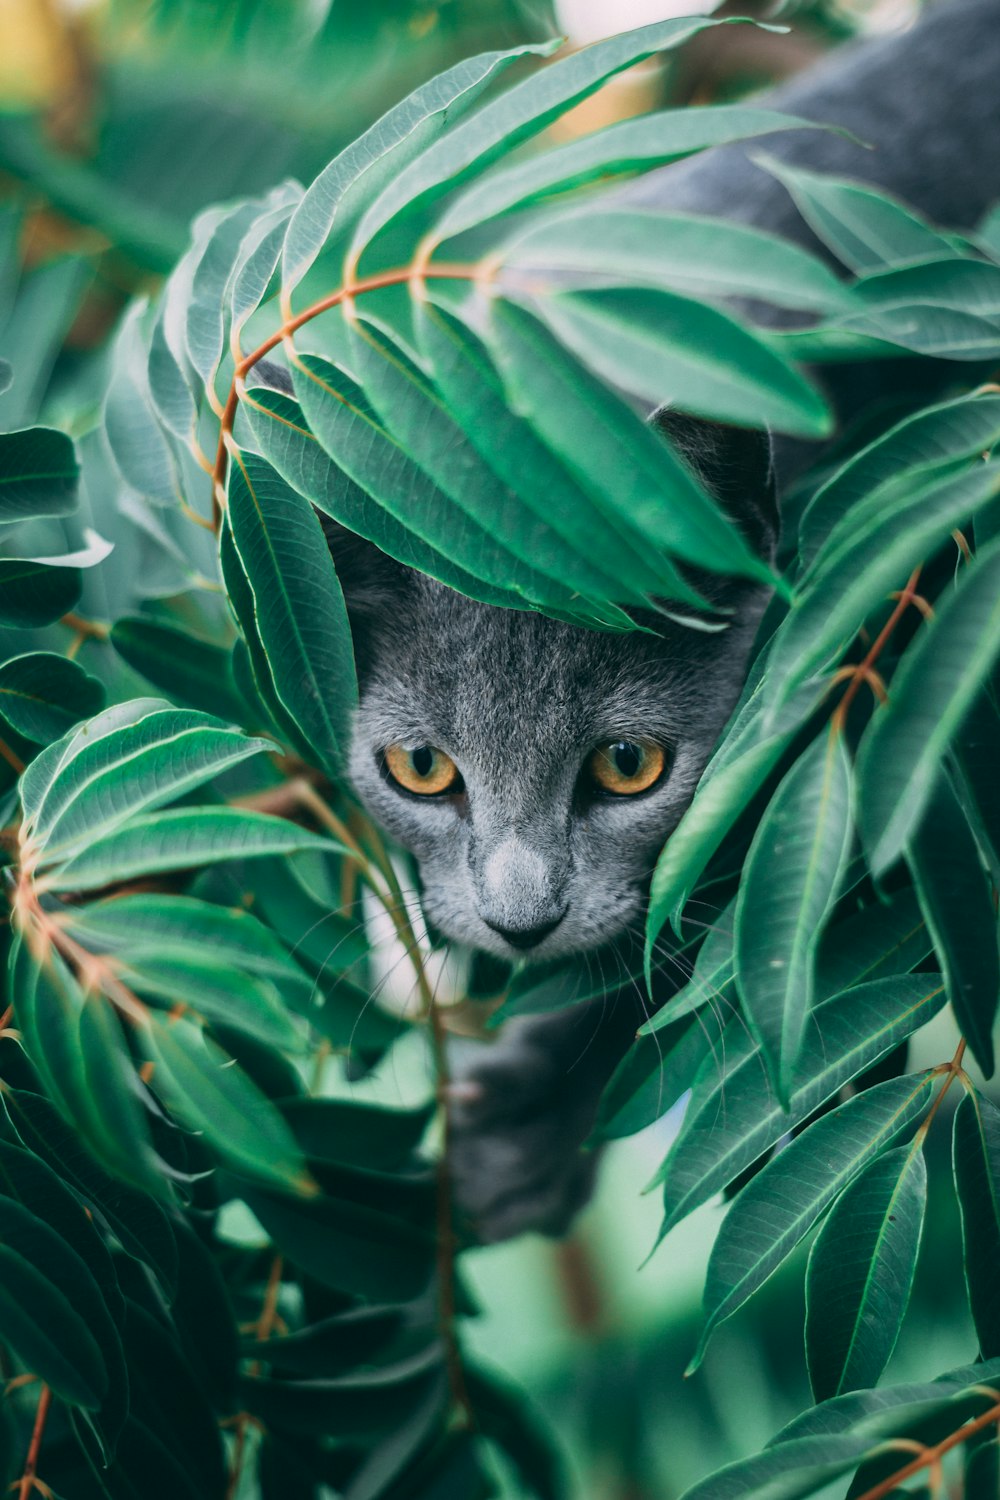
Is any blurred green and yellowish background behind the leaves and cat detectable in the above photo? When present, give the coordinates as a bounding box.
[0,0,959,1500]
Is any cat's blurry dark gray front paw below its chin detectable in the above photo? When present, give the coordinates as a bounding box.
[448,1037,597,1244]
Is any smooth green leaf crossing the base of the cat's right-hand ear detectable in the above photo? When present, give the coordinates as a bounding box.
[486,299,774,584]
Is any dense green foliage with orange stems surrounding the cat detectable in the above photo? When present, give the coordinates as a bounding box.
[0,8,1000,1500]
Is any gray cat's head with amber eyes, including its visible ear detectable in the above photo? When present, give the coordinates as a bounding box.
[328,414,777,960]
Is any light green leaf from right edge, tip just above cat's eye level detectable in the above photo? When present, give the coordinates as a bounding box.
[768,464,1000,707]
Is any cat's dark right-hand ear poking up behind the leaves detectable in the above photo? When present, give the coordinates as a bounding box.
[651,407,780,563]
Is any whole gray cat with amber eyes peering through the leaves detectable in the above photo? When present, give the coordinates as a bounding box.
[305,0,1000,1241]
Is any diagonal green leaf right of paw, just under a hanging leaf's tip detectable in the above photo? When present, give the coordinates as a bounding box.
[649,974,945,1239]
